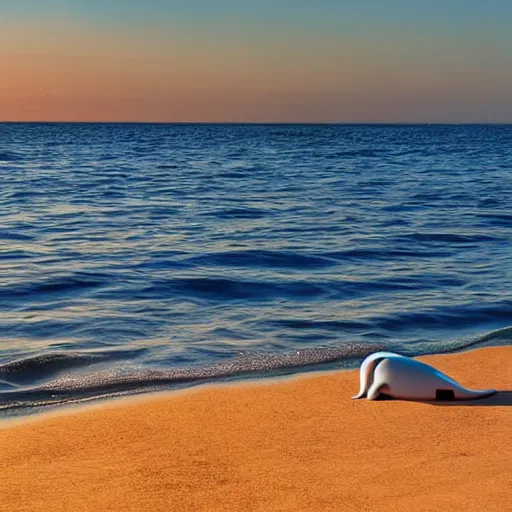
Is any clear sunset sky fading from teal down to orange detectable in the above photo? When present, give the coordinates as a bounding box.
[0,0,512,123]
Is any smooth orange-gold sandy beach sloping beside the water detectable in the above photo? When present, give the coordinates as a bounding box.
[0,347,512,512]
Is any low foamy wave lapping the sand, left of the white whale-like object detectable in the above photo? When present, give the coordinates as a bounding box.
[0,343,383,413]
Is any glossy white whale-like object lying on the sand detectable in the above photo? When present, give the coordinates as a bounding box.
[353,352,496,401]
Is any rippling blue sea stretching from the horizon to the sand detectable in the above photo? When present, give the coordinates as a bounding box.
[0,124,512,415]
